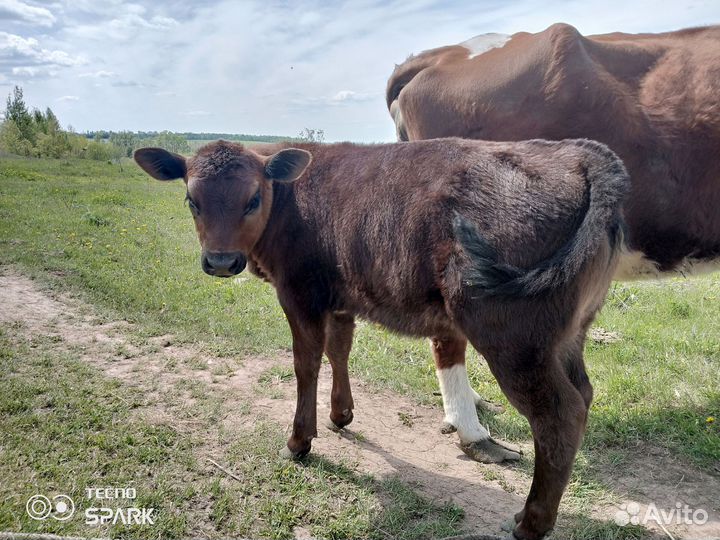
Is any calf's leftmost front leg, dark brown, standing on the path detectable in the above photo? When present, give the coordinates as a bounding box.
[281,315,325,458]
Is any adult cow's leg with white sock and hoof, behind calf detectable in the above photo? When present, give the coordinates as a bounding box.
[431,336,520,463]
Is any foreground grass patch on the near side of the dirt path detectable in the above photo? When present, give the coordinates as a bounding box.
[0,329,462,540]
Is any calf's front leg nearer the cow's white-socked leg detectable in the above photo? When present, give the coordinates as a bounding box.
[325,313,355,431]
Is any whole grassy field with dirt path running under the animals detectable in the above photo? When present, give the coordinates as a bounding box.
[0,154,720,540]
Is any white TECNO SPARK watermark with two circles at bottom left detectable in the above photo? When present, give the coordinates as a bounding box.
[25,487,155,525]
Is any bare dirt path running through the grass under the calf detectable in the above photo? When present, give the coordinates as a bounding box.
[0,270,720,539]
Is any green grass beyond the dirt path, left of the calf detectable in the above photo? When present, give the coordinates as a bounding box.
[0,159,290,354]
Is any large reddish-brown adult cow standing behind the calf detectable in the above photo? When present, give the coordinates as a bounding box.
[387,24,720,442]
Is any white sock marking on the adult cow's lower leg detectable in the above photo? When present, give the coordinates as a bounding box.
[437,364,490,443]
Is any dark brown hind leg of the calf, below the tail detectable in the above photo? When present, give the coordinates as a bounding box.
[478,347,592,540]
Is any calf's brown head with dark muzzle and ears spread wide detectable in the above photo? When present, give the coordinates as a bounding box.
[134,141,311,277]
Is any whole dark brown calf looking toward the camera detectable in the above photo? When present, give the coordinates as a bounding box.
[135,139,627,540]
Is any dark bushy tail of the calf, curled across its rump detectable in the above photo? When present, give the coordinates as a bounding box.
[453,140,629,297]
